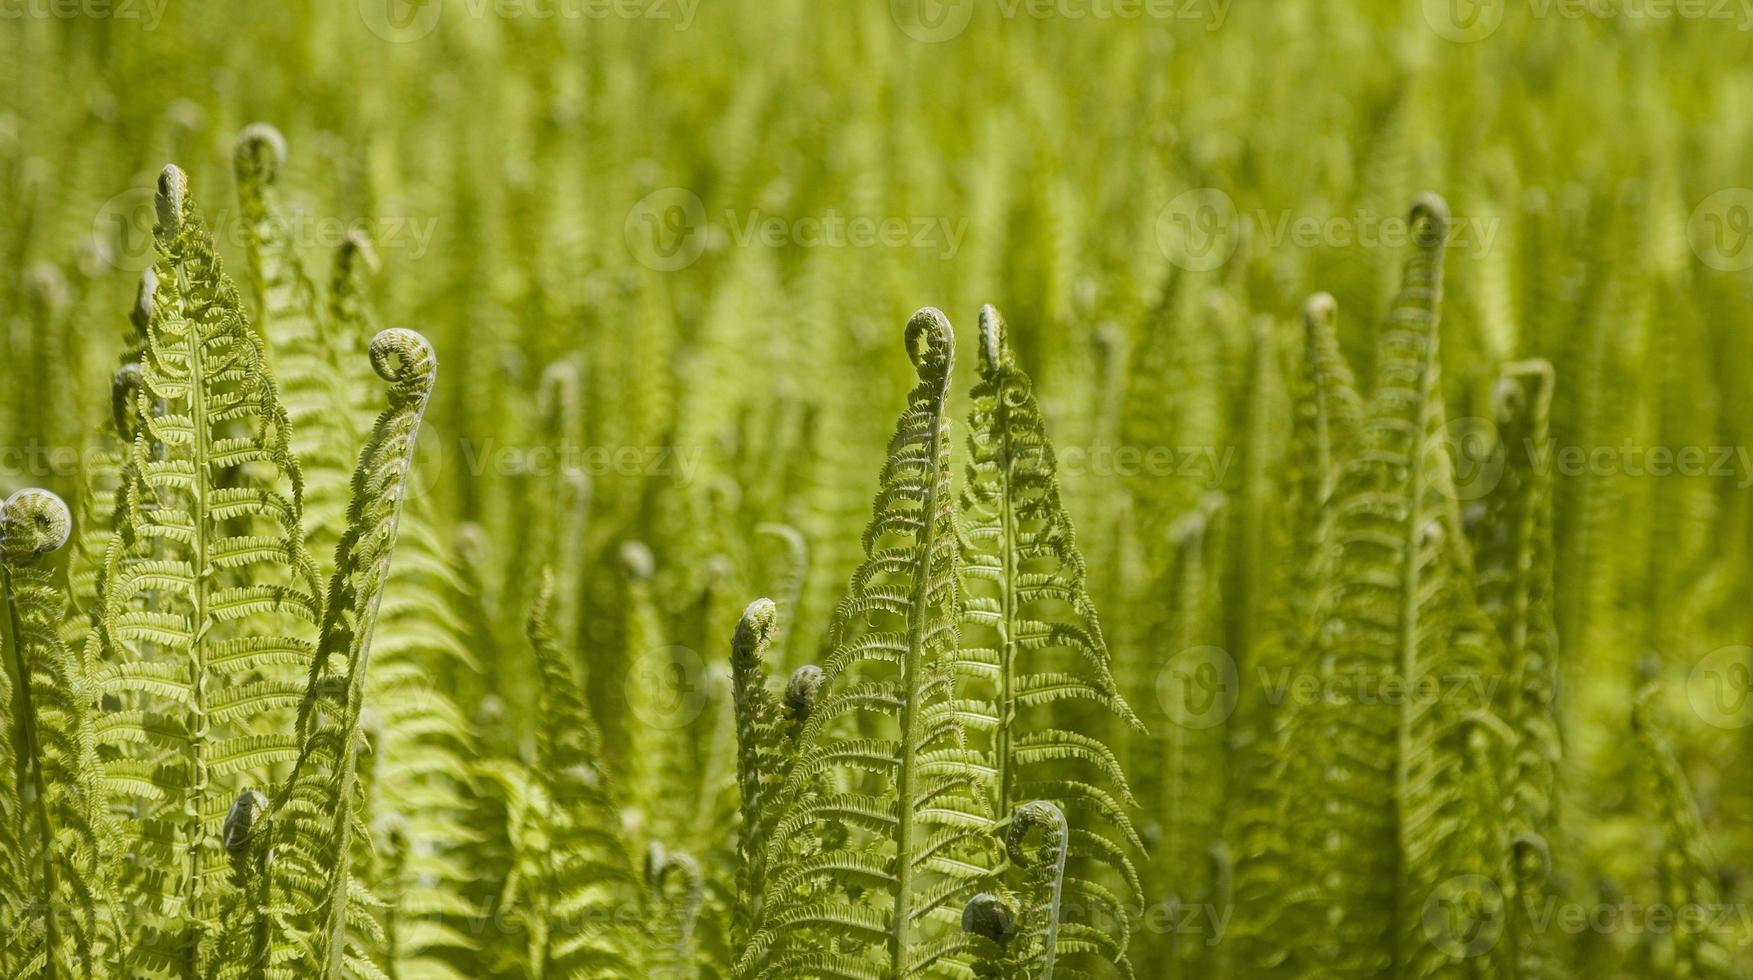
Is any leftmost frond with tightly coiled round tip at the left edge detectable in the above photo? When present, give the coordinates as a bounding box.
[0,489,116,978]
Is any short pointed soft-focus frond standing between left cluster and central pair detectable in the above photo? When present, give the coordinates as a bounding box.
[515,573,645,978]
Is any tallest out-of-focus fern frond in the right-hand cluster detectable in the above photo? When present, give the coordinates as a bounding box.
[1287,195,1502,976]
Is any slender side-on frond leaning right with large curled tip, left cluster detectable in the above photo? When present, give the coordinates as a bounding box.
[250,330,438,980]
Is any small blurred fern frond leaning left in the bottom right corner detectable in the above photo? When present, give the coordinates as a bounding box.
[1632,687,1749,980]
